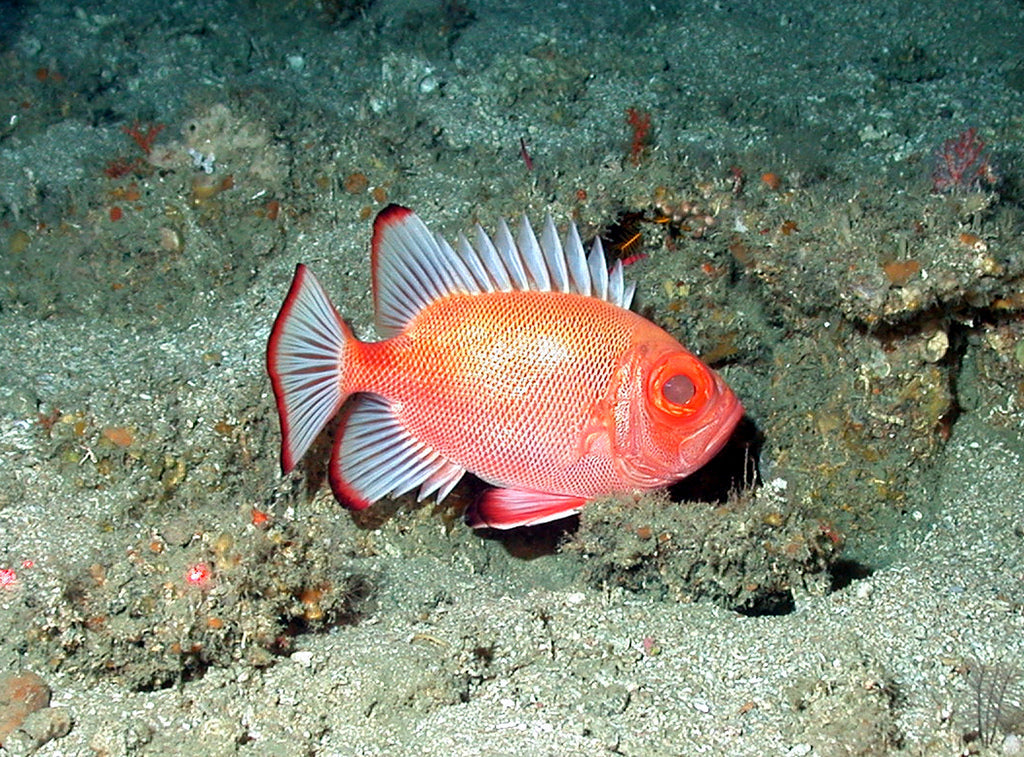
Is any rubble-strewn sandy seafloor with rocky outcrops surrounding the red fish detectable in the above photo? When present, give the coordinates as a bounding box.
[0,0,1024,756]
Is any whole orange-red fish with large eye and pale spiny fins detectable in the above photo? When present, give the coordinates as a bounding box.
[267,205,743,529]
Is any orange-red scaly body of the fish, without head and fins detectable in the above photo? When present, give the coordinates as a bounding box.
[364,293,636,495]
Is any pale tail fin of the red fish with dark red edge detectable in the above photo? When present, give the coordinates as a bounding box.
[266,263,354,473]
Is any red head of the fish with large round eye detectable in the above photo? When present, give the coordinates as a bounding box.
[614,330,743,489]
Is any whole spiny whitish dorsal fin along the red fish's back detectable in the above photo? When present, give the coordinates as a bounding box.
[373,205,634,337]
